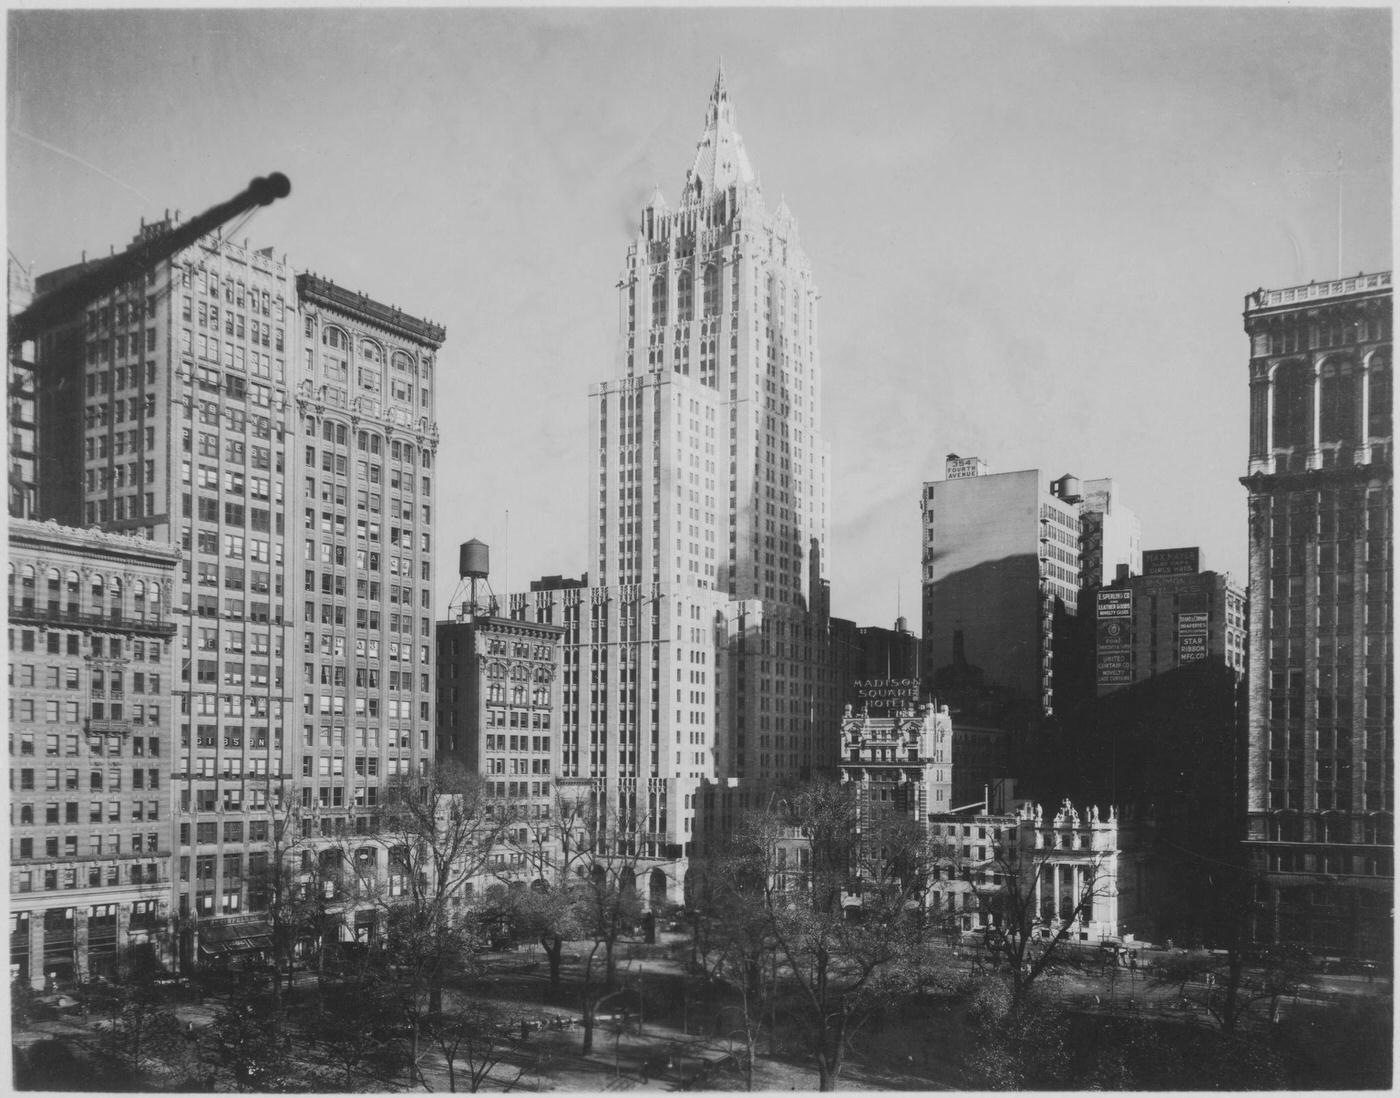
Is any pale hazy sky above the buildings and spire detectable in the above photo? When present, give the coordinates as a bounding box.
[7,7,1392,629]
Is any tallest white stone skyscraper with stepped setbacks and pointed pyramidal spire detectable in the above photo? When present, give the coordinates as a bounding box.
[511,69,837,890]
